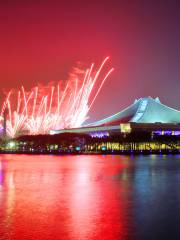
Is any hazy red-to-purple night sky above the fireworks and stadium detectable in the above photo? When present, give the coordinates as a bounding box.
[0,0,180,122]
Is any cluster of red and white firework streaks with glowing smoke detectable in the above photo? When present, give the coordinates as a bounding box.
[0,57,113,137]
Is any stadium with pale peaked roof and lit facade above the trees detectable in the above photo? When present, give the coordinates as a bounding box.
[50,97,180,137]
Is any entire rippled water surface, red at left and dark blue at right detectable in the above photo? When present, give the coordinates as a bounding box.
[0,155,180,240]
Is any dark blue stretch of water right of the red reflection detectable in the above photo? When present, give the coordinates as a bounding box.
[132,155,180,239]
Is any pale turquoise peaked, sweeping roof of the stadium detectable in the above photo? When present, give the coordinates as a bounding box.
[87,97,180,127]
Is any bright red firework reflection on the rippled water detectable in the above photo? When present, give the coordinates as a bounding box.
[0,155,131,240]
